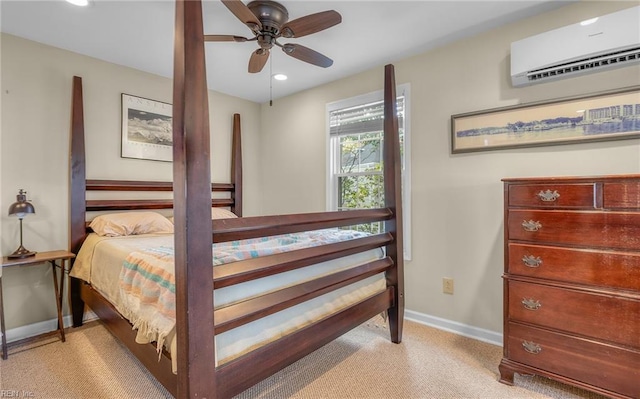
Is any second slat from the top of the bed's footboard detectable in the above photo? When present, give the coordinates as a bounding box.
[213,233,393,288]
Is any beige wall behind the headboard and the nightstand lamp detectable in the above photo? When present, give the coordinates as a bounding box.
[0,34,261,329]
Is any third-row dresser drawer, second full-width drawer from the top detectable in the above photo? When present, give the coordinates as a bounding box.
[507,243,640,291]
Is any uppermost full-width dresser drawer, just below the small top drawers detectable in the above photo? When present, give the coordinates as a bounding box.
[507,209,640,250]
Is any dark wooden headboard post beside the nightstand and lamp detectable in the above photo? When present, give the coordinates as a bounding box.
[69,76,86,327]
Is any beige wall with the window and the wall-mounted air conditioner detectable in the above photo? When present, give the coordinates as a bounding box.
[261,1,640,332]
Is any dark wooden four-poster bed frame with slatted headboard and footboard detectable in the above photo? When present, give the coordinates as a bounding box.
[70,0,404,398]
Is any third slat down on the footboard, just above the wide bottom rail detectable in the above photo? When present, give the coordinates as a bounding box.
[213,258,393,334]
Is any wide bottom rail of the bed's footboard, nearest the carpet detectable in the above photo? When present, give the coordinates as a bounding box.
[216,287,395,398]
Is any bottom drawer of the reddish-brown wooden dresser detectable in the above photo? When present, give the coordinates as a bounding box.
[506,323,640,398]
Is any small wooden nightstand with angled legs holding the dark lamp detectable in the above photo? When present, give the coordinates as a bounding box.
[0,250,75,359]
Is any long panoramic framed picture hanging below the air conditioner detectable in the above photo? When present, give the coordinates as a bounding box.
[451,86,640,153]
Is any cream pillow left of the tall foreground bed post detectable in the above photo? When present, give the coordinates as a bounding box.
[89,212,173,237]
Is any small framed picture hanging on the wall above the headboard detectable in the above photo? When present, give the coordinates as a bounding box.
[122,93,173,162]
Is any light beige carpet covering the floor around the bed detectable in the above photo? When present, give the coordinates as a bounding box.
[0,319,603,399]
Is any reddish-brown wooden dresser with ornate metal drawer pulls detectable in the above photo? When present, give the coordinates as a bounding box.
[499,175,640,399]
